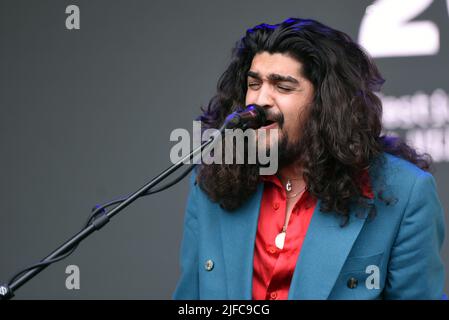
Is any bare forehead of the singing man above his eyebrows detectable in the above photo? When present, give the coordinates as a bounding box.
[250,52,302,79]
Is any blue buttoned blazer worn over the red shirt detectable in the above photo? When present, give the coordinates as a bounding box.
[173,153,444,299]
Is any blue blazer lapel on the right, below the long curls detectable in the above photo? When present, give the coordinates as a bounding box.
[288,200,369,300]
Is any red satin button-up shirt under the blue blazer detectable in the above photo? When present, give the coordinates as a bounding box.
[253,171,374,300]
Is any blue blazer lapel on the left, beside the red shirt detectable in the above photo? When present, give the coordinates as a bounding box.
[220,183,263,300]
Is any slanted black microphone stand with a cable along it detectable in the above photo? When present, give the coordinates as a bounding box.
[0,121,228,300]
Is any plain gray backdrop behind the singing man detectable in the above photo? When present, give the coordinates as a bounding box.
[0,0,449,299]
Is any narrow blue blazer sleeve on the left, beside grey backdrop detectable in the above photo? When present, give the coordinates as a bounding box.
[173,171,199,300]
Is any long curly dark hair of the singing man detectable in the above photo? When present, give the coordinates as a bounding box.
[197,18,431,225]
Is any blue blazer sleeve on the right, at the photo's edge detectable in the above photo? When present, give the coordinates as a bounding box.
[384,173,445,299]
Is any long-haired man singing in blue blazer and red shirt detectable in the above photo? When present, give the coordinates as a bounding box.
[174,19,444,300]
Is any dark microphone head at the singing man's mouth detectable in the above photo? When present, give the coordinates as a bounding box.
[224,104,267,129]
